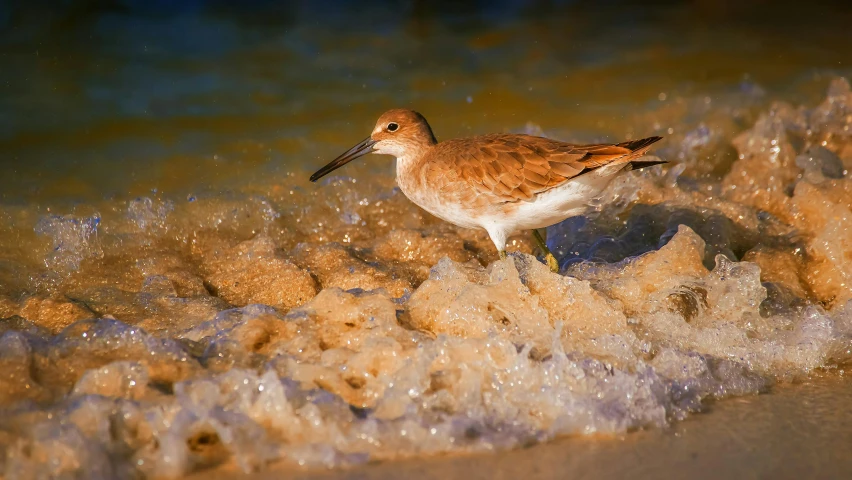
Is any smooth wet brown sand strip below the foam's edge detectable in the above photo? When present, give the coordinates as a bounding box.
[201,373,852,480]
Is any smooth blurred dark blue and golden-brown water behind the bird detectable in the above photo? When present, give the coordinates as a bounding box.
[0,0,852,205]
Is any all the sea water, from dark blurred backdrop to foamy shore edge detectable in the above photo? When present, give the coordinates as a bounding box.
[0,1,852,478]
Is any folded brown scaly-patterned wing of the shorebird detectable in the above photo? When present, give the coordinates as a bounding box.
[450,134,660,202]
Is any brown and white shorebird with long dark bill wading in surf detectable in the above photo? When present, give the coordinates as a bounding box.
[311,109,665,272]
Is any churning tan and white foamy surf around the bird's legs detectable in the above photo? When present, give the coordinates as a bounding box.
[0,80,852,478]
